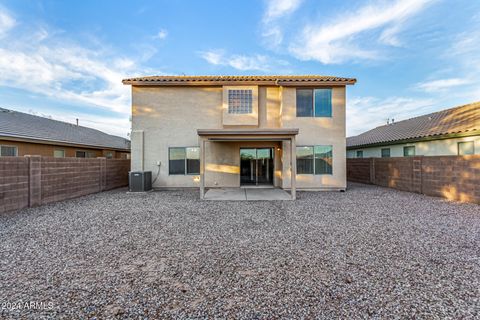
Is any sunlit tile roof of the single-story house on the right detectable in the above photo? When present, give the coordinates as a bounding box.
[347,102,480,148]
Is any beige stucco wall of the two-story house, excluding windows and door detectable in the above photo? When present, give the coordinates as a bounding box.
[131,86,346,189]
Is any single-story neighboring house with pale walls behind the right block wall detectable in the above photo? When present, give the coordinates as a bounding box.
[347,102,480,158]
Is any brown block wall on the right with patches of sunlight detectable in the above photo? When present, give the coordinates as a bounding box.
[347,155,480,203]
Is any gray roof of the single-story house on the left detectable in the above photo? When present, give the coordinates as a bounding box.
[0,108,130,150]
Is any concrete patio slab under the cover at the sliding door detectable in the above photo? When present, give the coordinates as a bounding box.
[205,188,291,201]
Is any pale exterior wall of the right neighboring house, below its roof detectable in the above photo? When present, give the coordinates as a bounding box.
[347,135,480,158]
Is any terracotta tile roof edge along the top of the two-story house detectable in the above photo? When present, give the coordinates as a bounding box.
[122,75,357,85]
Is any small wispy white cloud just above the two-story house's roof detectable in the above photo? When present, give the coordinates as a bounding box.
[200,50,288,71]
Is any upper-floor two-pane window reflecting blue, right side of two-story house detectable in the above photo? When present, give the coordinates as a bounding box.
[297,89,332,117]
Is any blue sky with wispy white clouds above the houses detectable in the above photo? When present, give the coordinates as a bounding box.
[0,0,480,136]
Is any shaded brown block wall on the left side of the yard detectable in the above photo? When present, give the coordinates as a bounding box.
[0,156,130,213]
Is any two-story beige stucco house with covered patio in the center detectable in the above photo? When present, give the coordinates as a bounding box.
[123,75,356,198]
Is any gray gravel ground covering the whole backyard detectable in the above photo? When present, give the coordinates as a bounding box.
[0,184,480,319]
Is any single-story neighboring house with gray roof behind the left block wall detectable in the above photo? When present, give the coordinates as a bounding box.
[0,108,130,159]
